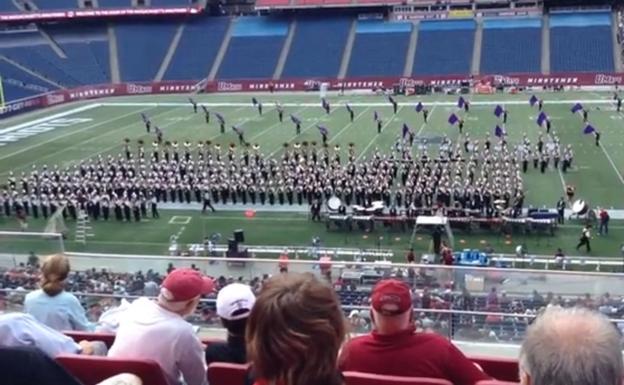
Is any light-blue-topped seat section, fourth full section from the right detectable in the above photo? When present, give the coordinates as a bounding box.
[347,20,412,77]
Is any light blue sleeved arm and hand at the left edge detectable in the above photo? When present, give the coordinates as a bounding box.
[0,313,106,358]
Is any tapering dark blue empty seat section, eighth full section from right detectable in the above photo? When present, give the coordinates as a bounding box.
[115,23,178,82]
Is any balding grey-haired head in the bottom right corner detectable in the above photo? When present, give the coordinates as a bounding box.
[520,307,624,385]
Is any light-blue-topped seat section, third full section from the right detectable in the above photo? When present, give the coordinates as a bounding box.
[413,20,475,75]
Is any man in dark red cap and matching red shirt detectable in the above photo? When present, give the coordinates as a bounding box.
[339,279,490,385]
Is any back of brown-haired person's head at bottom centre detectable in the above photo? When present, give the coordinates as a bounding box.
[246,273,346,385]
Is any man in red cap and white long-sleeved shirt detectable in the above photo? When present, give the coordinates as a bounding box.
[108,269,214,385]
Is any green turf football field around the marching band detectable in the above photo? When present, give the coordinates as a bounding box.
[0,92,624,258]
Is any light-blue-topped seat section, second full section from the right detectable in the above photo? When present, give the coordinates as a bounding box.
[480,18,542,74]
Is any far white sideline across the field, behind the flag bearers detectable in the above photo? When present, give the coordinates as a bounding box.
[100,99,613,109]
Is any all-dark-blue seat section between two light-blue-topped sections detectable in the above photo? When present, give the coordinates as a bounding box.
[282,17,352,78]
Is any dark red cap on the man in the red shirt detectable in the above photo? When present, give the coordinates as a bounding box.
[371,279,412,316]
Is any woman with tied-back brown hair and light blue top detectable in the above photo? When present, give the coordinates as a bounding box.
[24,254,93,331]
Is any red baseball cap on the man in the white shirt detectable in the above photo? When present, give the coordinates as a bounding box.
[160,268,214,302]
